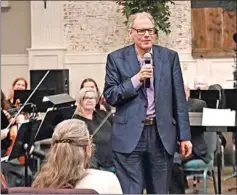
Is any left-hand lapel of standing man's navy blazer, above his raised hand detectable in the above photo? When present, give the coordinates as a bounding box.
[125,44,147,97]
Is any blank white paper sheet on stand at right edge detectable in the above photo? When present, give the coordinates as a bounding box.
[202,108,236,127]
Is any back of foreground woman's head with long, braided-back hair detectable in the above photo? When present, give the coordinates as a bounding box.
[32,119,92,188]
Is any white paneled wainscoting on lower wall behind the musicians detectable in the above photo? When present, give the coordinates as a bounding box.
[1,51,234,90]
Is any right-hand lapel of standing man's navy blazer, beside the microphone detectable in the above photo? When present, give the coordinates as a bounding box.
[152,46,163,101]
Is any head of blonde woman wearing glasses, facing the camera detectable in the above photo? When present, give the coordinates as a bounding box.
[75,87,98,115]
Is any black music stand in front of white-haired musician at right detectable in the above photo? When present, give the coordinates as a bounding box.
[190,90,220,108]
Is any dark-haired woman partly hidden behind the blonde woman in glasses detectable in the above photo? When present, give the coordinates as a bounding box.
[80,78,111,112]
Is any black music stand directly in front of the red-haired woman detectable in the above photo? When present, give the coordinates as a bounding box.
[13,90,55,112]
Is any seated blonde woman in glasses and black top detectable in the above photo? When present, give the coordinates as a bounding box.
[73,88,113,170]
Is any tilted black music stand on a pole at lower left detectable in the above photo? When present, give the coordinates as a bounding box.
[7,120,41,187]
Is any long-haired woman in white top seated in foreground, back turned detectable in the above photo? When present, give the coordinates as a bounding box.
[32,119,122,194]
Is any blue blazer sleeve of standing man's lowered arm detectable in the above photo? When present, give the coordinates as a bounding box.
[173,53,191,141]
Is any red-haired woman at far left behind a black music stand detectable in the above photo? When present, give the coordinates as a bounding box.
[8,77,28,107]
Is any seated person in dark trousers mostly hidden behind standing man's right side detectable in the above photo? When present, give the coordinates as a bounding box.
[169,85,211,194]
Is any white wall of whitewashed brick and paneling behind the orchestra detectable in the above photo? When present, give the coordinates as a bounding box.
[1,1,234,99]
